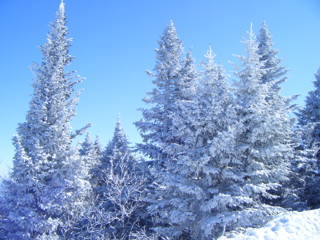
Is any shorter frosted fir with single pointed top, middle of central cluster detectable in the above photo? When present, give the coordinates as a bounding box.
[192,48,239,239]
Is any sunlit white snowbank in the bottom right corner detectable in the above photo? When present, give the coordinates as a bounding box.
[219,209,320,240]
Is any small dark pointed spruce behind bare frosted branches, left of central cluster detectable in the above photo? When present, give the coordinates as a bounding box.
[80,118,146,239]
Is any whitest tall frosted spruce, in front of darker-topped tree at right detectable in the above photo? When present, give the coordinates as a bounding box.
[230,25,292,227]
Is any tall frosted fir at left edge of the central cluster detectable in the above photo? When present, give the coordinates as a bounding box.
[135,21,186,238]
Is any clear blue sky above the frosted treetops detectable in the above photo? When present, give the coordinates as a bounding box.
[0,0,320,175]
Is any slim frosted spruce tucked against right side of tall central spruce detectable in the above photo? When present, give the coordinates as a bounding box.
[149,50,199,237]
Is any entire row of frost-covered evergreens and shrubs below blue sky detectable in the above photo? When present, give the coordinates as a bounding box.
[0,2,320,240]
